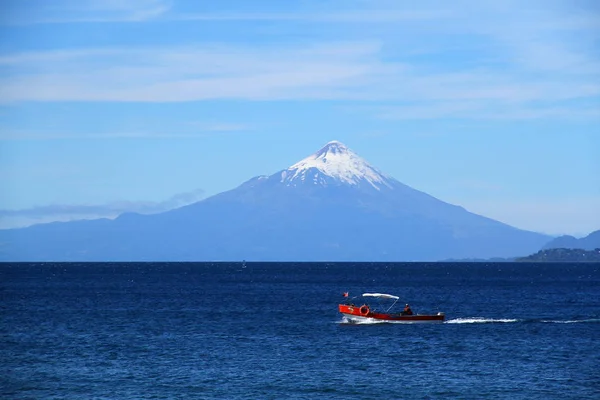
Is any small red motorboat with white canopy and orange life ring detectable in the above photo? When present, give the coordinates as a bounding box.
[339,293,446,324]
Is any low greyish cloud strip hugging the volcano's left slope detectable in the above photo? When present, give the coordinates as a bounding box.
[0,189,205,229]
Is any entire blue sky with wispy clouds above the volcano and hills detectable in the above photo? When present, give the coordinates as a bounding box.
[0,0,600,235]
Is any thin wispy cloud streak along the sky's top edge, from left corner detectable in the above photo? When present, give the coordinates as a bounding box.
[0,0,453,25]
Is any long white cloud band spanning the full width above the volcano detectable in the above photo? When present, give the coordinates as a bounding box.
[0,43,600,110]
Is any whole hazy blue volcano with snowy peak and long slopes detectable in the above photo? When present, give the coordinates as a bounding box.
[0,142,549,261]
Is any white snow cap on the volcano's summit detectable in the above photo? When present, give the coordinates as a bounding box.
[281,140,392,190]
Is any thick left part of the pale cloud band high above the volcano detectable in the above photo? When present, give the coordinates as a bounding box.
[0,43,380,102]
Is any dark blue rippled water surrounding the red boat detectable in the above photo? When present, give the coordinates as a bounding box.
[0,263,600,399]
